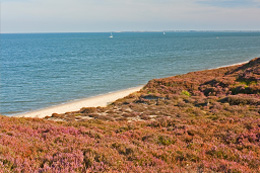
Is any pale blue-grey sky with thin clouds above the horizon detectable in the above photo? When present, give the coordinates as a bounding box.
[0,0,260,33]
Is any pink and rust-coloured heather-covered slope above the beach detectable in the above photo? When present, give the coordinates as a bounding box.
[0,58,260,172]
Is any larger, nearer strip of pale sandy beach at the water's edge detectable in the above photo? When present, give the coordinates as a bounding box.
[13,86,143,118]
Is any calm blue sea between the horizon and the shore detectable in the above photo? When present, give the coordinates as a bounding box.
[0,32,260,115]
